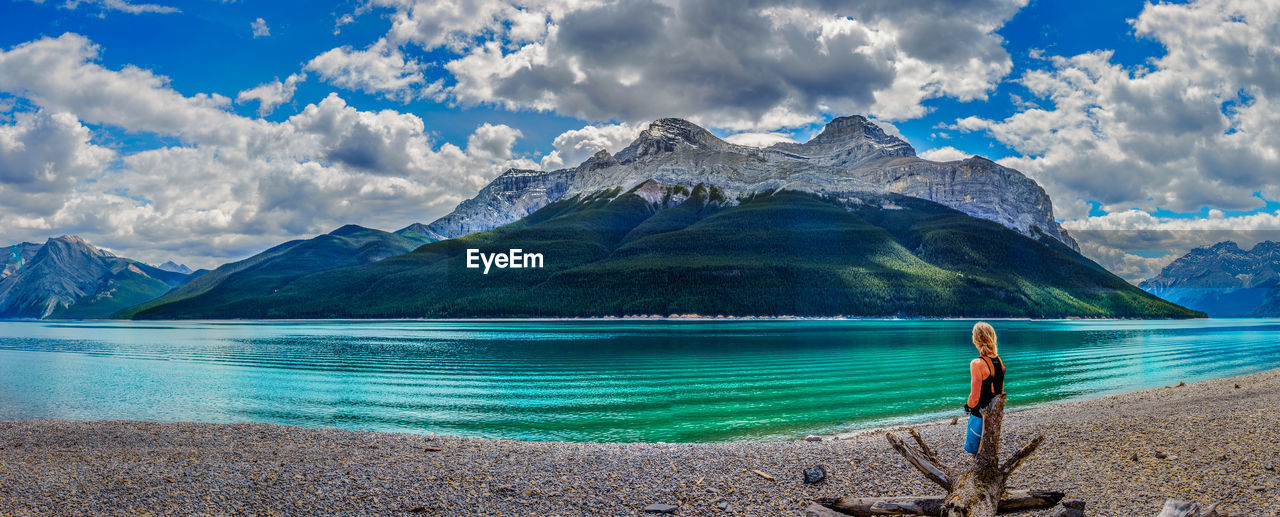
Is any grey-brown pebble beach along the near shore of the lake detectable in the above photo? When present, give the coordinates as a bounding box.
[0,370,1280,516]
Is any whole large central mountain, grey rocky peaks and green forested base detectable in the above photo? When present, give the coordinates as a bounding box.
[118,116,1187,319]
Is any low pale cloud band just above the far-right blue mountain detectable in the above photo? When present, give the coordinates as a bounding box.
[1064,210,1280,283]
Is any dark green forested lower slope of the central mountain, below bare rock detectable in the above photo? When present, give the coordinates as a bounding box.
[138,182,1198,317]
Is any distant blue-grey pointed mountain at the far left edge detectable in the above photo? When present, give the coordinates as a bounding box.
[0,235,187,319]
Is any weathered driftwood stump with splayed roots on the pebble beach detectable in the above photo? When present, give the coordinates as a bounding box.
[819,394,1062,517]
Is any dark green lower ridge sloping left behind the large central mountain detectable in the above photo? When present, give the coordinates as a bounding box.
[116,224,429,317]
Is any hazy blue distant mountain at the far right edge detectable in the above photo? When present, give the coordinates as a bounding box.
[1139,241,1280,317]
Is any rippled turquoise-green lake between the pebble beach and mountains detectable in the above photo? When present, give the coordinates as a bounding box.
[0,320,1280,441]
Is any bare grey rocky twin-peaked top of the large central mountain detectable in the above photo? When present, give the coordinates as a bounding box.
[401,116,1079,250]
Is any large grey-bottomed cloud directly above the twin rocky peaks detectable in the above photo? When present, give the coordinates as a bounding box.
[348,0,1025,132]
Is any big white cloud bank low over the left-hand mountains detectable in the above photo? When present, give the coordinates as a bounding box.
[0,35,536,266]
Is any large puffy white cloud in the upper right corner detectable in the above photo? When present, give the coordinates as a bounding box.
[954,0,1280,216]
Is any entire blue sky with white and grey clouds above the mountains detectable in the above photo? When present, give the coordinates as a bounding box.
[0,0,1280,280]
